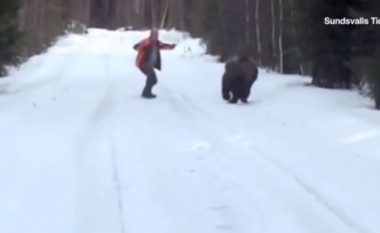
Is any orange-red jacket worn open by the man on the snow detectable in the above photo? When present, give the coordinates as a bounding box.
[133,38,175,70]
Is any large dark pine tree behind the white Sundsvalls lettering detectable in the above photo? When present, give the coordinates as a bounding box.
[297,0,359,88]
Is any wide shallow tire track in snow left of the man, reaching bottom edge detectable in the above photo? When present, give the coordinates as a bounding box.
[73,50,126,233]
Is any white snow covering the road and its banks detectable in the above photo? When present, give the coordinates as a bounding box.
[0,29,380,233]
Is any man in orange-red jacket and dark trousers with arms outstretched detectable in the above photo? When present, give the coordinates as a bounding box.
[133,29,175,99]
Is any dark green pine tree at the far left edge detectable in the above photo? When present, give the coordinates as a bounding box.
[0,0,22,77]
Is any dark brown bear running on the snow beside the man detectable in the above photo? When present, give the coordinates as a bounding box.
[222,56,258,103]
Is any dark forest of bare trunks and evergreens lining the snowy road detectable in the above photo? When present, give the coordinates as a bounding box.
[0,0,380,109]
